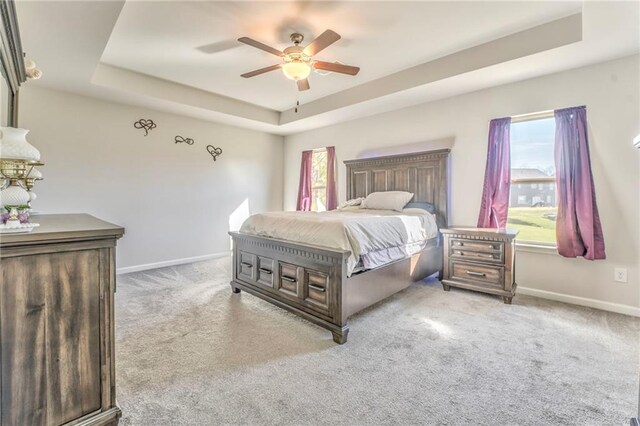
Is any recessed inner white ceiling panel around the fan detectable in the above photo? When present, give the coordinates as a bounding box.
[102,2,581,111]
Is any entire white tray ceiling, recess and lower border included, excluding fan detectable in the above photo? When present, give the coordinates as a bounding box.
[16,0,640,134]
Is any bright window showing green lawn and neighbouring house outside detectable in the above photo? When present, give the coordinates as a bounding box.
[507,113,557,245]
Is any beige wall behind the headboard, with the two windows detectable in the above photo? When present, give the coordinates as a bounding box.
[284,56,640,312]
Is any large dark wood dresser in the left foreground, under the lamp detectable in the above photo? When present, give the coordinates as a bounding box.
[0,214,124,426]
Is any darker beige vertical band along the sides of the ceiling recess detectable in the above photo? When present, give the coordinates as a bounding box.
[91,13,582,133]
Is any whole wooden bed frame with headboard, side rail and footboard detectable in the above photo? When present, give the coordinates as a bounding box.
[229,149,449,344]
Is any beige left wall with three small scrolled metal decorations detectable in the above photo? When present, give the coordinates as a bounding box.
[19,84,283,267]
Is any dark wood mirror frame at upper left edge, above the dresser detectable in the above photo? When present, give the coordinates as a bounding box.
[0,0,27,127]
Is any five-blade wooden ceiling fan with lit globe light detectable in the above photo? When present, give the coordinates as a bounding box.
[238,30,360,91]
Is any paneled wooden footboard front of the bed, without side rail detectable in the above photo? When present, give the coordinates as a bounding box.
[229,232,351,344]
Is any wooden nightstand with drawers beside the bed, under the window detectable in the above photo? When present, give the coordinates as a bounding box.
[440,227,518,304]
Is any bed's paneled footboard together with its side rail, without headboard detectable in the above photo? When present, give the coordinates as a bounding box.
[229,232,442,344]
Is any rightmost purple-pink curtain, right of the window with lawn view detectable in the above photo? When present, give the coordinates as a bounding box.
[555,106,606,260]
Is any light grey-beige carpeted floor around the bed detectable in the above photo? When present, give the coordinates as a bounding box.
[116,258,640,426]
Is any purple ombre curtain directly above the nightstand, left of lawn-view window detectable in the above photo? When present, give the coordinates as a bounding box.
[478,117,511,228]
